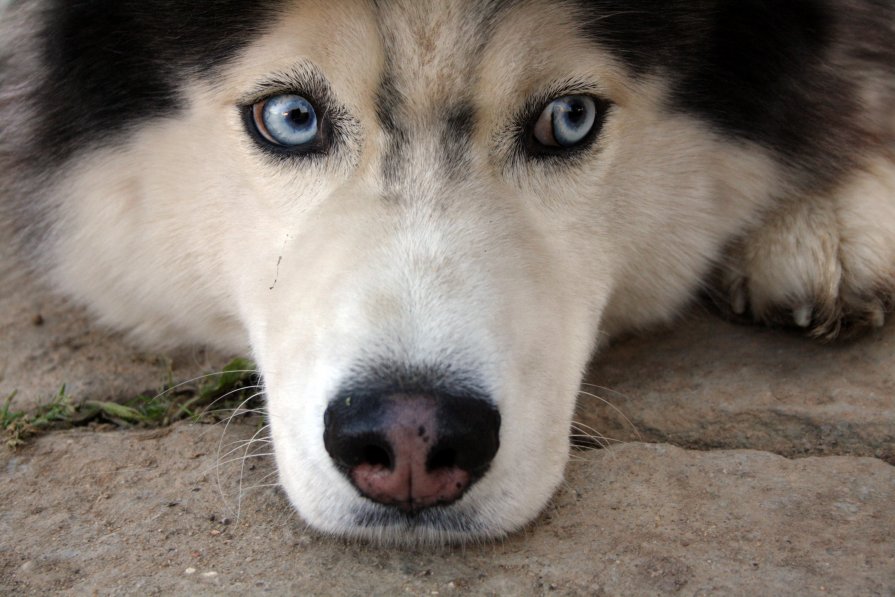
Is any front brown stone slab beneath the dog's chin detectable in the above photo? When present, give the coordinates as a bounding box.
[0,424,895,595]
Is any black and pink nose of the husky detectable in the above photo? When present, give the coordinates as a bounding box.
[323,393,500,512]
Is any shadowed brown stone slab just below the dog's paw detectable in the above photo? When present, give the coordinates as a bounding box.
[577,312,895,464]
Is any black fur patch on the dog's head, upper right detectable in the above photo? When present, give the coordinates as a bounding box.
[582,0,895,185]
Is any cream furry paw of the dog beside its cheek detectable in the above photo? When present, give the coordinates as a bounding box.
[721,161,895,339]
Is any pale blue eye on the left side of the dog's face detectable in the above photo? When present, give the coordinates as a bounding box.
[252,95,320,148]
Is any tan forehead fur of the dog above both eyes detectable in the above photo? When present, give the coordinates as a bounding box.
[231,0,624,110]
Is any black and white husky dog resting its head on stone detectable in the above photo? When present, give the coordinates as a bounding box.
[0,0,895,542]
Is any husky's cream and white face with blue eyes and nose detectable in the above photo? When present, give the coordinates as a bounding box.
[40,0,764,541]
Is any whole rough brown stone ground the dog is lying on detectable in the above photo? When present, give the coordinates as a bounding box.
[0,262,895,595]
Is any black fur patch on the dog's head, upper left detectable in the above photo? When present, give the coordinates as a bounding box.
[37,0,281,165]
